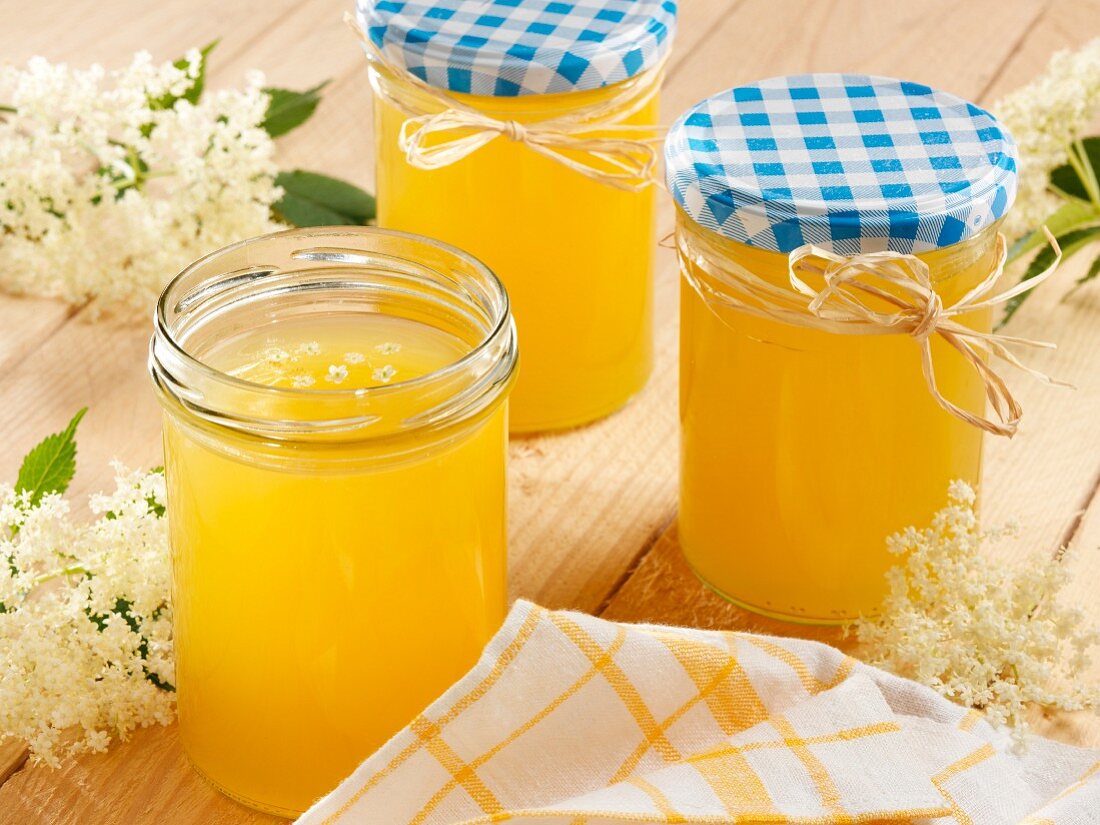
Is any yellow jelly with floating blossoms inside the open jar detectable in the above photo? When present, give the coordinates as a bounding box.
[165,315,506,815]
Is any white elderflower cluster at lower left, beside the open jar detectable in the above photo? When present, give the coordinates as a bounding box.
[0,465,175,766]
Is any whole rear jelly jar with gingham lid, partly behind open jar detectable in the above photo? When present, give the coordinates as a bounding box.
[359,0,677,432]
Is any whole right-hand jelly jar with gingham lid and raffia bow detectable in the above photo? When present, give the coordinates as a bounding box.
[666,74,1016,624]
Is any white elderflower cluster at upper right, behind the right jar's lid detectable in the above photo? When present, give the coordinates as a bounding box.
[993,37,1100,240]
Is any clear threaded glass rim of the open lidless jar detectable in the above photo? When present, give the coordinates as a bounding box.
[149,227,518,437]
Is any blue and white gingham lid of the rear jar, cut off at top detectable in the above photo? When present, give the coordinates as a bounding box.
[358,0,677,97]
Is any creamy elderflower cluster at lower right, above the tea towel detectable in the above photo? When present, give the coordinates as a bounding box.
[856,482,1100,744]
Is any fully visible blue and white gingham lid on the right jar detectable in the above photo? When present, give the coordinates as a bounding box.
[664,74,1016,255]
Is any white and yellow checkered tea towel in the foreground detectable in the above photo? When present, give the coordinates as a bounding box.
[299,602,1100,825]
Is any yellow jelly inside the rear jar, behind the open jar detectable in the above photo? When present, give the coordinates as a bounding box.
[375,78,657,432]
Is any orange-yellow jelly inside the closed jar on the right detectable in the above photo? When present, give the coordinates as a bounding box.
[679,213,996,624]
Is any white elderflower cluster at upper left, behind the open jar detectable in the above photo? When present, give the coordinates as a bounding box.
[0,51,282,311]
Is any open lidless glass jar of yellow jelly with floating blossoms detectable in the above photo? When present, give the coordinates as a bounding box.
[150,228,517,816]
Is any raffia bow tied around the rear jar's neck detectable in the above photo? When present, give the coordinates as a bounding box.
[344,13,663,191]
